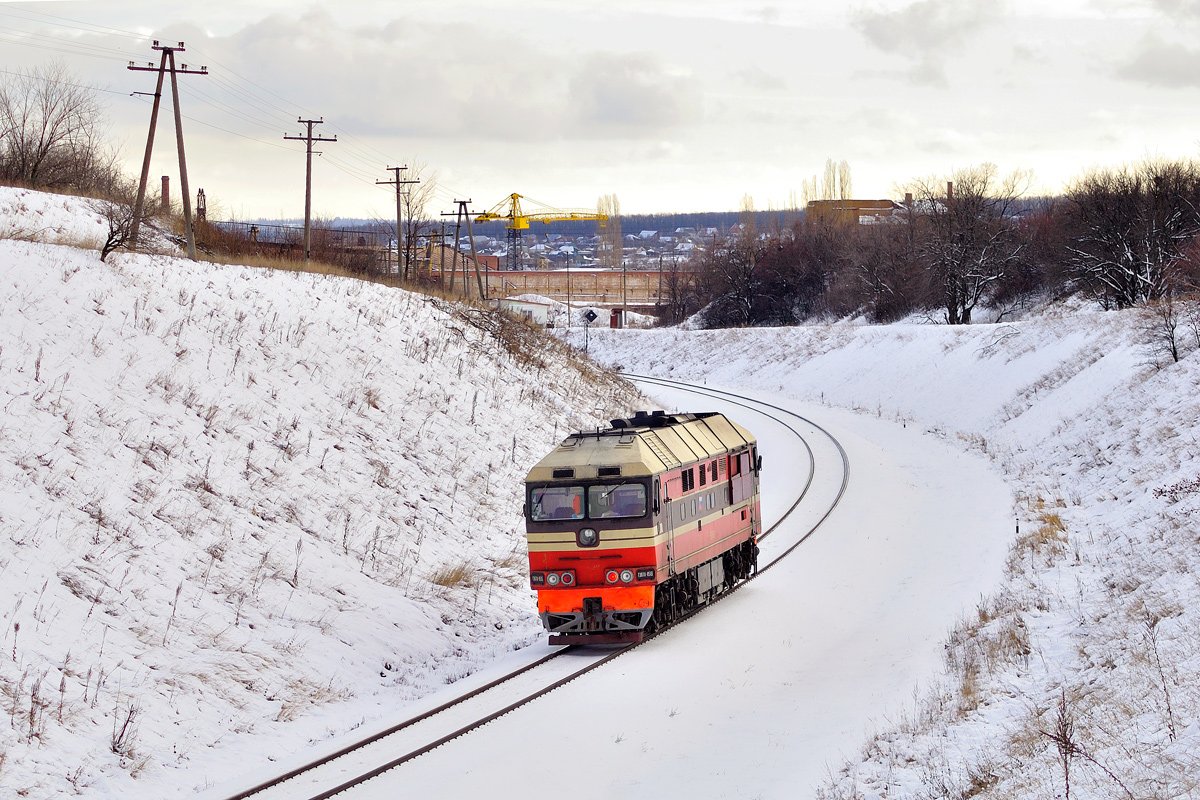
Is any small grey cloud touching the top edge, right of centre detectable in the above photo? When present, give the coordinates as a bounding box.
[851,0,1007,58]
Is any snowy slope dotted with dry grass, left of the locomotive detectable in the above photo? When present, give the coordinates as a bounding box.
[0,190,638,798]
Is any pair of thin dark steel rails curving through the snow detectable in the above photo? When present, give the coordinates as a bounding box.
[226,374,850,800]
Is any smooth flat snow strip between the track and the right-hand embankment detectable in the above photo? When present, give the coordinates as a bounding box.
[347,387,1013,800]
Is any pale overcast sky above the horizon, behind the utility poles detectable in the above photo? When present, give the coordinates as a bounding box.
[0,0,1200,218]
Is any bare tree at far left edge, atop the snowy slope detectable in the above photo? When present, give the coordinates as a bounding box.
[0,62,119,192]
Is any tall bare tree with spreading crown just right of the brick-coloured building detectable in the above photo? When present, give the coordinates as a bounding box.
[907,164,1033,325]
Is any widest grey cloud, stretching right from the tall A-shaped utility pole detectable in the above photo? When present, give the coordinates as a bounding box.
[178,11,696,142]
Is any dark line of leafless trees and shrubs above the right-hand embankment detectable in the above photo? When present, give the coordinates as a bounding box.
[666,158,1200,327]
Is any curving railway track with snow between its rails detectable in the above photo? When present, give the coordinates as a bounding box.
[214,374,850,800]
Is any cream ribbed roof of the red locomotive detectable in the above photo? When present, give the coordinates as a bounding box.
[526,411,755,481]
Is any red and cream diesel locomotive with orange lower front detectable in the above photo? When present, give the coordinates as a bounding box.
[524,411,762,644]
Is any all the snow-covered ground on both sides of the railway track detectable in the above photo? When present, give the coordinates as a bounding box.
[0,184,1200,800]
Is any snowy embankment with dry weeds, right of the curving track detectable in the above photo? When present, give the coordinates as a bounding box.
[585,312,1200,798]
